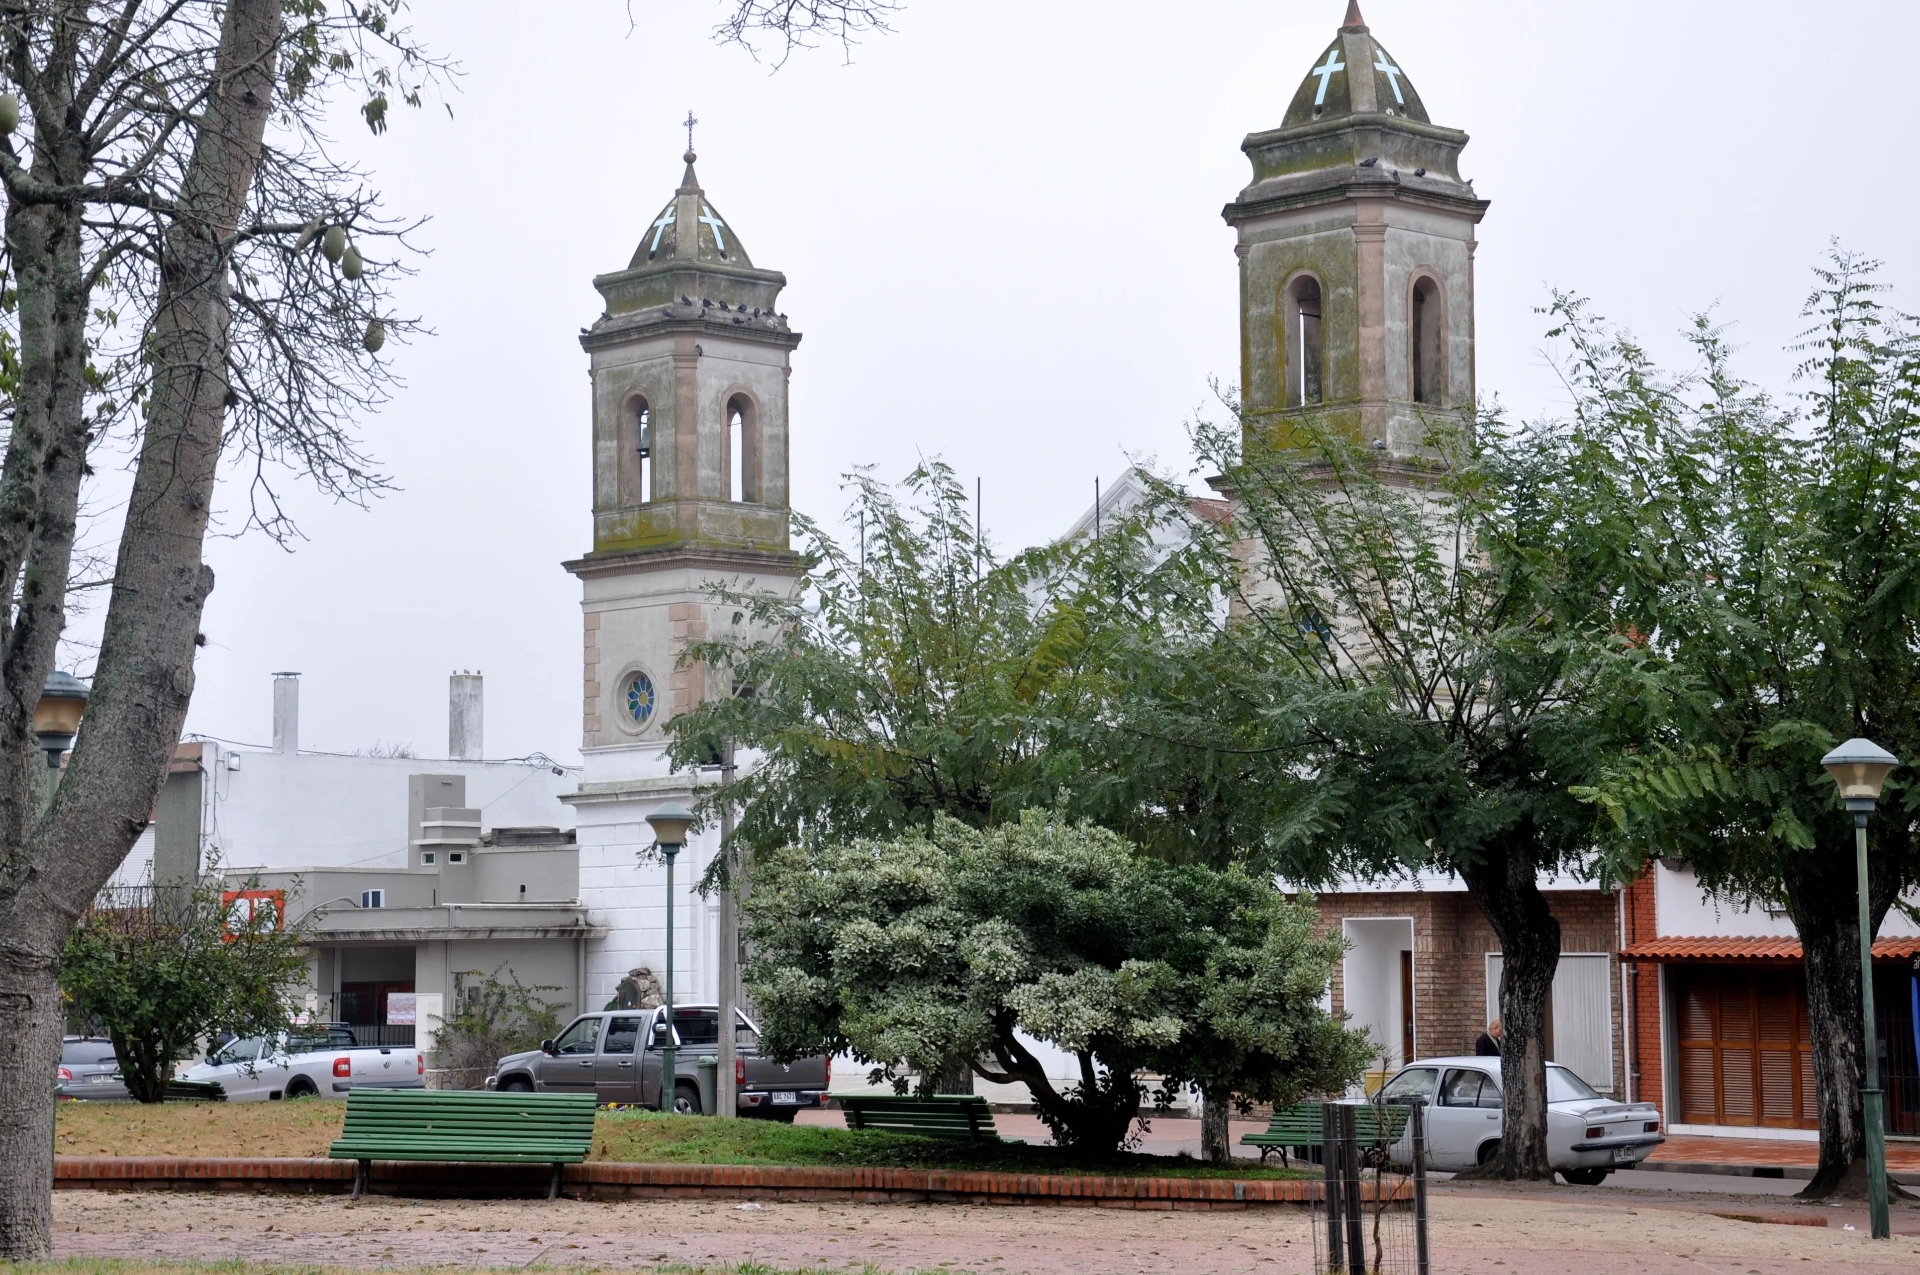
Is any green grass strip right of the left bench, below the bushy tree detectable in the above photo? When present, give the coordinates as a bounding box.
[593,1112,1304,1177]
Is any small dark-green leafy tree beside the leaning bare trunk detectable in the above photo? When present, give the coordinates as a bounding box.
[60,876,307,1102]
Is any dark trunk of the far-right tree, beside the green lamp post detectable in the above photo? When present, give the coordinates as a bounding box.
[1782,830,1903,1200]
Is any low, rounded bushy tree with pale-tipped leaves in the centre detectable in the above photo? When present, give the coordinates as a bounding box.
[745,812,1367,1150]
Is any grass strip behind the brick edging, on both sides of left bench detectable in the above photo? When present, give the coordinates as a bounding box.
[54,1098,1302,1177]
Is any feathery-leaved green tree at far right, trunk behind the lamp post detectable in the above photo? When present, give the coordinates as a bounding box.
[1555,250,1920,1196]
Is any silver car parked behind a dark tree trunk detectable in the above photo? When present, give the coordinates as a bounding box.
[1380,1058,1667,1187]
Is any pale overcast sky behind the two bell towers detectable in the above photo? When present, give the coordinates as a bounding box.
[101,0,1920,760]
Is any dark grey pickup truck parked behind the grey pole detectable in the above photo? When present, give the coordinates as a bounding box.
[486,1004,831,1123]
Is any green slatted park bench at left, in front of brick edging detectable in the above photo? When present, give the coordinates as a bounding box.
[326,1089,595,1200]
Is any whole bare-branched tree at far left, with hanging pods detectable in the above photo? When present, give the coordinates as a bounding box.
[0,0,445,1260]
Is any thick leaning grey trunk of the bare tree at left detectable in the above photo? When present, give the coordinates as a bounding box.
[0,0,280,1262]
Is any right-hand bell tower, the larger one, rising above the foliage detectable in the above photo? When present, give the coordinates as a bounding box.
[1223,0,1488,457]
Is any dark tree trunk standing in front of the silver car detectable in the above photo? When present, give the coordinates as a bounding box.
[1461,837,1561,1181]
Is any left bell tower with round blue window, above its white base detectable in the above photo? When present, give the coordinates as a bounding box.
[566,148,801,756]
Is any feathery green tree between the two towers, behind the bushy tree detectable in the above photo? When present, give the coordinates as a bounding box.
[670,461,1212,870]
